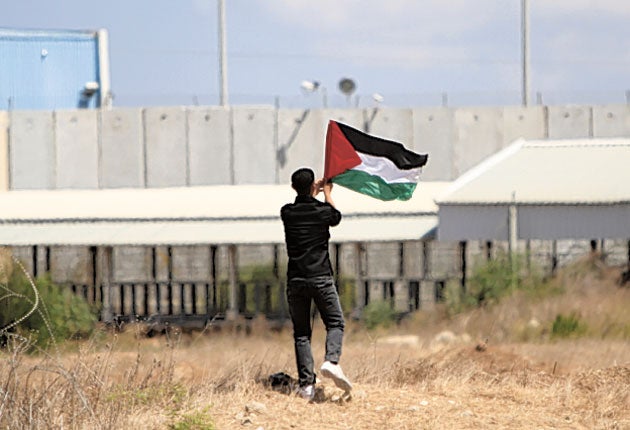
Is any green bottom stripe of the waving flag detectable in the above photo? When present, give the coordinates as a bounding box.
[332,170,417,200]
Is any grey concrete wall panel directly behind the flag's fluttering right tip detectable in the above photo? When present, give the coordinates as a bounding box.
[412,108,455,181]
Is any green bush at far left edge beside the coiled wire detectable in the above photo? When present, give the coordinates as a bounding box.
[0,268,97,346]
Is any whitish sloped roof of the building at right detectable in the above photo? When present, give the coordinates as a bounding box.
[437,139,630,205]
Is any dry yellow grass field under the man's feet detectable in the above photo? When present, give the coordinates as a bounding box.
[0,256,630,430]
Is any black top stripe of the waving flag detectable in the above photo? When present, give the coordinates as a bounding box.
[337,122,429,170]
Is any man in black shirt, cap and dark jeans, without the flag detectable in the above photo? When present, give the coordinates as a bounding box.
[280,168,352,400]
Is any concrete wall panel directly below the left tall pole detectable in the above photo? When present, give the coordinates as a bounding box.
[187,108,232,185]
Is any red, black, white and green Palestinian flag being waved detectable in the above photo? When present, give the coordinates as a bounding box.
[324,120,428,200]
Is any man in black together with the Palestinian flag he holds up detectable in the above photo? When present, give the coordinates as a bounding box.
[280,120,428,400]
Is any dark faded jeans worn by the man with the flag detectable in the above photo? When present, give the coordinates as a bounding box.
[287,276,345,387]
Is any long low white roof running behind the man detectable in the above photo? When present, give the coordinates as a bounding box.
[0,182,447,246]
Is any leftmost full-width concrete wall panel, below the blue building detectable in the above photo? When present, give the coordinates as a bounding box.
[9,111,55,190]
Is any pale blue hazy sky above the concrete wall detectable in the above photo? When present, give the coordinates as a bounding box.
[0,0,630,107]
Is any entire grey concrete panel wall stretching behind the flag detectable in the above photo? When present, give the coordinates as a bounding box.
[0,105,630,189]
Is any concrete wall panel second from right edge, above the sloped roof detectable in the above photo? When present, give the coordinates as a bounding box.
[547,106,591,139]
